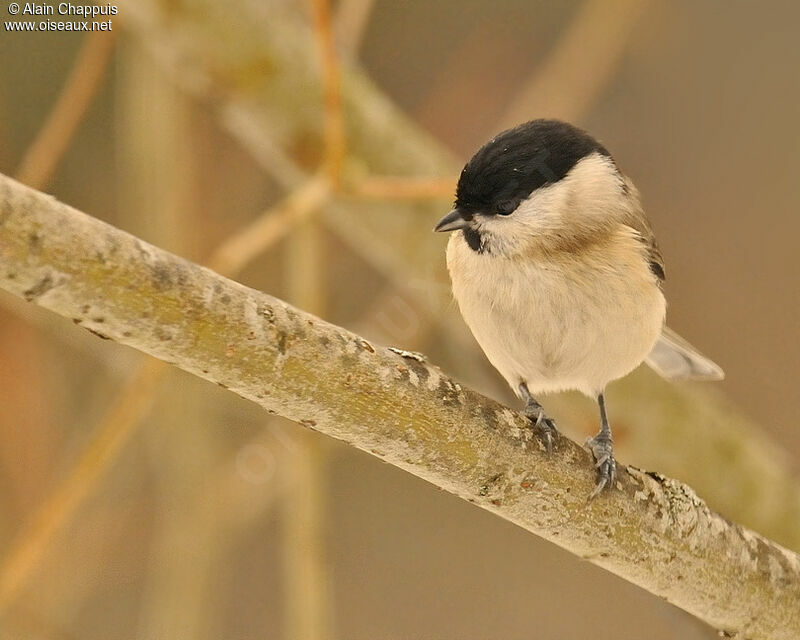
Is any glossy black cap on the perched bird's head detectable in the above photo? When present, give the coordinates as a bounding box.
[456,120,611,218]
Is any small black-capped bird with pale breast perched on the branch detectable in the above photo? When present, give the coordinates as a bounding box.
[435,120,723,496]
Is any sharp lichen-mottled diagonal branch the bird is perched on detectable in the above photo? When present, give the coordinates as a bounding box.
[0,176,800,639]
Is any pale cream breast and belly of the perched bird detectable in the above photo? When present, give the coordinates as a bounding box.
[447,230,666,395]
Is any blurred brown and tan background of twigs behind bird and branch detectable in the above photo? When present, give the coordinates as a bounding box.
[0,0,800,640]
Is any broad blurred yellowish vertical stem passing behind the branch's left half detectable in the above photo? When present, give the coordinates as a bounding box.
[115,44,225,640]
